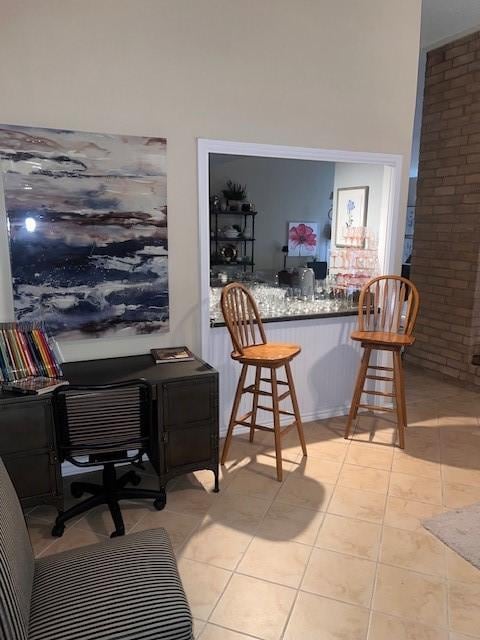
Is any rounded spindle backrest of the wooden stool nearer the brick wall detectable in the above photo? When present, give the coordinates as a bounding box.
[358,276,419,336]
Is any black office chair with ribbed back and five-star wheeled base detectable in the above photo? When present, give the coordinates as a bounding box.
[52,380,166,538]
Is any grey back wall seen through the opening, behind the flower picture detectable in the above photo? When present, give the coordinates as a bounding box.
[210,156,334,272]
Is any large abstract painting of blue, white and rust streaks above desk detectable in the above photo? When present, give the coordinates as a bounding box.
[0,125,169,339]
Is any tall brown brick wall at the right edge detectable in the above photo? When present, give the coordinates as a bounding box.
[407,32,480,385]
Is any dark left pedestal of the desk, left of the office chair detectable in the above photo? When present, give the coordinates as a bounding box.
[0,396,63,508]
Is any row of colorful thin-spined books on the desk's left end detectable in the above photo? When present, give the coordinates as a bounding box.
[0,322,62,382]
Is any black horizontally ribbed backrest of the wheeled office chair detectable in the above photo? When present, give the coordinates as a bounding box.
[53,380,151,466]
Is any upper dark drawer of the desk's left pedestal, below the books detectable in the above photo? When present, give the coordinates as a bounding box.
[0,400,54,456]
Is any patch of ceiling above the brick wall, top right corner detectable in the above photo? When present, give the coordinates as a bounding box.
[420,0,480,49]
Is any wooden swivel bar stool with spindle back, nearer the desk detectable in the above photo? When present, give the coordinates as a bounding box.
[220,282,307,482]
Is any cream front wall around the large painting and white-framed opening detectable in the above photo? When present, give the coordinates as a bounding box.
[0,0,420,359]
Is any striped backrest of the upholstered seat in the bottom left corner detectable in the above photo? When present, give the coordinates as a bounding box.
[0,459,34,640]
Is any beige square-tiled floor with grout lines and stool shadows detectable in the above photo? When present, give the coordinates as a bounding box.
[27,369,480,640]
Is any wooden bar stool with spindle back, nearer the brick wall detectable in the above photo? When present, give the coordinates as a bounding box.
[345,276,419,449]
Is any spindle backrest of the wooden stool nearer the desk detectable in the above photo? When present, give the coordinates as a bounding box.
[220,282,267,356]
